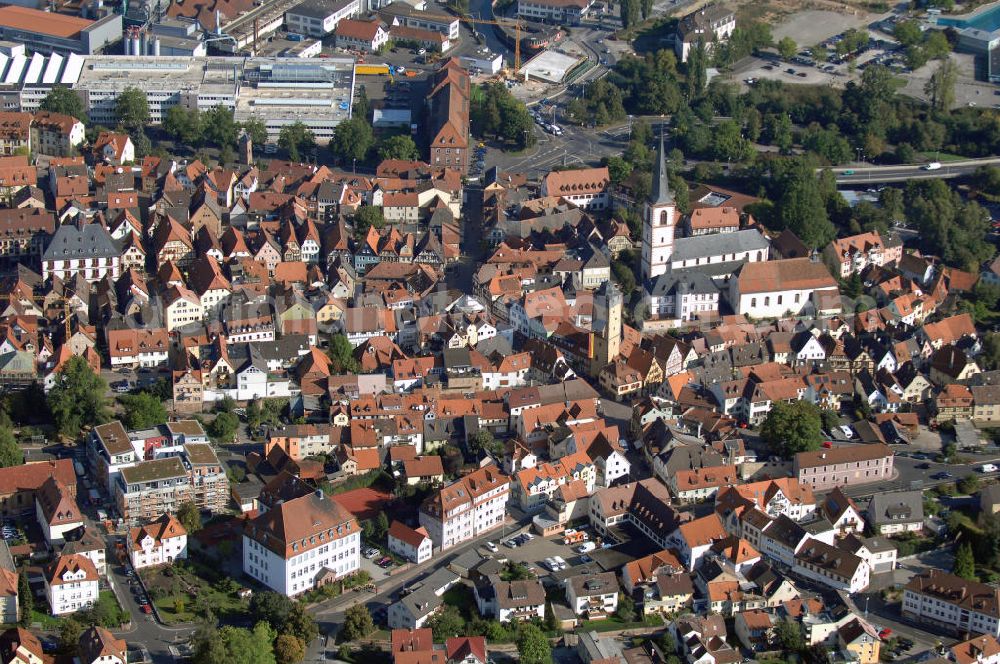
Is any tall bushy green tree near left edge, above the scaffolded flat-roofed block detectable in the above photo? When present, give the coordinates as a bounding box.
[48,355,108,436]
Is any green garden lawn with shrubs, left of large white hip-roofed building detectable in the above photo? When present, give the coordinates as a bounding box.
[143,564,247,624]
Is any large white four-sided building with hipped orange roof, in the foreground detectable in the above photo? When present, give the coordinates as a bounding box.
[243,491,361,597]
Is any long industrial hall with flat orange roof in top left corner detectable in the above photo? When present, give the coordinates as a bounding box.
[0,5,122,55]
